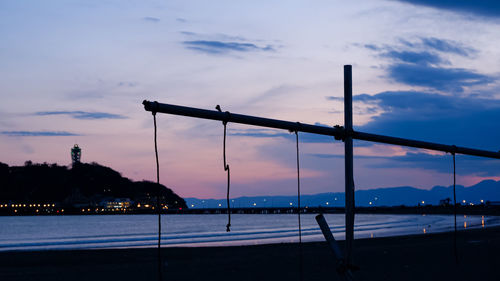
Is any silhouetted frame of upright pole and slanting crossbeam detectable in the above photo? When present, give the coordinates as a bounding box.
[143,65,500,265]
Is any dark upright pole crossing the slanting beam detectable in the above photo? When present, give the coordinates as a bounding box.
[344,65,354,265]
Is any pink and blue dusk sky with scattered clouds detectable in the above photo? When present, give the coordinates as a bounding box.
[0,0,500,198]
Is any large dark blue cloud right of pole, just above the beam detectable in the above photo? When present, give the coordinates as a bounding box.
[353,91,500,151]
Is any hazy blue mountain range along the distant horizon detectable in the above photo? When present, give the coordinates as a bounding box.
[184,180,500,208]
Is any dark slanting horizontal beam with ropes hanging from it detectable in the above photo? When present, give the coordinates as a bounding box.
[142,100,500,159]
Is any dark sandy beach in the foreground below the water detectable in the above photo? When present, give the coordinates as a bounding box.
[0,227,500,281]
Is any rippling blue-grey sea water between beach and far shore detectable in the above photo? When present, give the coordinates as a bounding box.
[0,214,494,251]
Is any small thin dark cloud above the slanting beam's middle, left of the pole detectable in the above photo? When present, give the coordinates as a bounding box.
[182,40,274,54]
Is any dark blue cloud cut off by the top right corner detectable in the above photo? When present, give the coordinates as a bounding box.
[399,0,500,18]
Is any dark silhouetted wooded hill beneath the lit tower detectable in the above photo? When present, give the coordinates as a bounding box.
[0,161,187,209]
